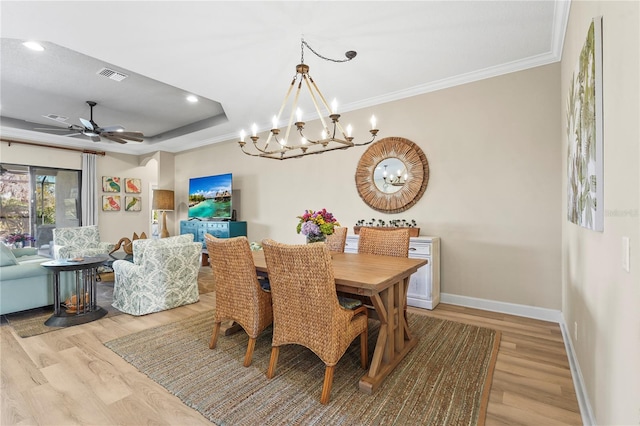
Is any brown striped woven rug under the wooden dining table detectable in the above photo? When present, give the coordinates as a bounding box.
[105,311,500,425]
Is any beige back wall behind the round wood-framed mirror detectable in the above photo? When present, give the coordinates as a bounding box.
[175,64,561,310]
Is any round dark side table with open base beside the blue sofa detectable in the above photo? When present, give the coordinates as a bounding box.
[41,256,109,327]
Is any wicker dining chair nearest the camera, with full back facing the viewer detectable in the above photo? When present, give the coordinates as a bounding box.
[262,240,368,404]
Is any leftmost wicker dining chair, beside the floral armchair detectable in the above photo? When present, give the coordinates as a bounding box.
[205,234,273,367]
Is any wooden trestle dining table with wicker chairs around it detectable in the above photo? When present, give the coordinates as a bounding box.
[253,251,427,394]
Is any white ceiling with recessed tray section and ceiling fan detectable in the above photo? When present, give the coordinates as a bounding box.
[0,0,569,154]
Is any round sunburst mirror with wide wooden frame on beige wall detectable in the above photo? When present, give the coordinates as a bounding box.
[356,137,429,213]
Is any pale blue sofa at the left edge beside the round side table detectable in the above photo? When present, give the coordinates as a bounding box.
[0,244,53,315]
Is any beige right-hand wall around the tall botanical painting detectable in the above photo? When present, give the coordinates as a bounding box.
[560,1,640,425]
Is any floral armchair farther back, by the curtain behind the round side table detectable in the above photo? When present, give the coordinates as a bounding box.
[53,225,115,259]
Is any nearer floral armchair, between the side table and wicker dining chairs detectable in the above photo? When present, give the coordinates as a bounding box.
[112,234,202,315]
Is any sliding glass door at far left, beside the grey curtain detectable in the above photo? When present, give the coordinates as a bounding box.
[0,164,82,254]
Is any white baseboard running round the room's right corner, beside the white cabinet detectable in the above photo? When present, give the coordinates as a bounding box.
[440,293,597,426]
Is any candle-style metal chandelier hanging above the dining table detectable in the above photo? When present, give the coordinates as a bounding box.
[238,38,378,160]
